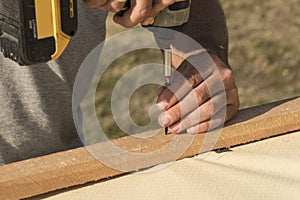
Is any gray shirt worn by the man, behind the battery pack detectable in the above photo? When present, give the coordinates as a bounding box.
[0,1,106,165]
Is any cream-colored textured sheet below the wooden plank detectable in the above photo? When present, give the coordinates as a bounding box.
[39,132,300,200]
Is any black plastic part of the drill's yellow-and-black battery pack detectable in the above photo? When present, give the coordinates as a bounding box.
[0,0,55,65]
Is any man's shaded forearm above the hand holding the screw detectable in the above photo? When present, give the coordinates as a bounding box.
[184,0,228,65]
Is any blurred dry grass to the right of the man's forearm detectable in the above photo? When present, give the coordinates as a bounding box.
[221,0,300,107]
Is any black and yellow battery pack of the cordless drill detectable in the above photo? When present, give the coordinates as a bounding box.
[0,0,78,65]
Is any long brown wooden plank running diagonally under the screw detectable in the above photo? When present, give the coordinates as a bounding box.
[0,97,300,199]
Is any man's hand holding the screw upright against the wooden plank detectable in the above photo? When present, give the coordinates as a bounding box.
[157,53,239,134]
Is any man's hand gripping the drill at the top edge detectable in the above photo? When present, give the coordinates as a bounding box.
[85,0,175,28]
